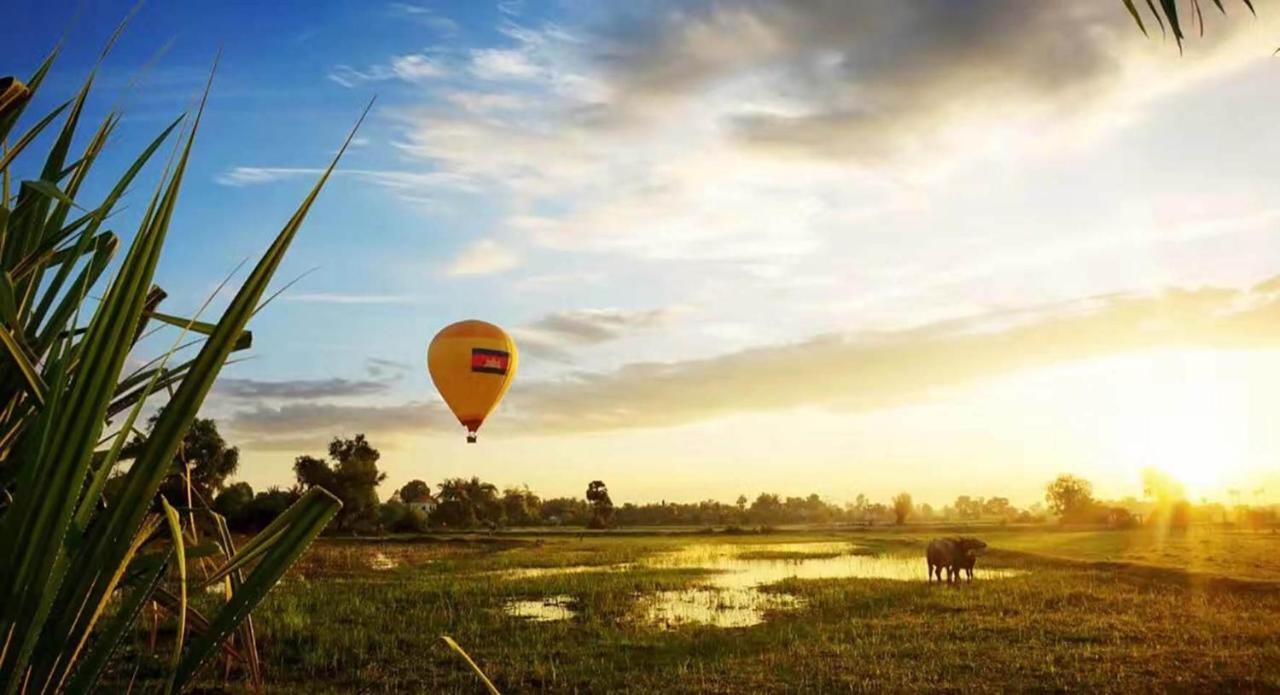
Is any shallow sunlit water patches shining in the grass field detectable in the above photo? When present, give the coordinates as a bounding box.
[507,543,1020,628]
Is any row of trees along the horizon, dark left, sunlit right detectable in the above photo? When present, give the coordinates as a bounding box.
[122,419,1276,535]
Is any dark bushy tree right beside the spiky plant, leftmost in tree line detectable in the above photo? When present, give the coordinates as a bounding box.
[122,412,239,507]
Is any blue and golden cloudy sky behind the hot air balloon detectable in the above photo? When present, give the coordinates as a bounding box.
[0,0,1280,504]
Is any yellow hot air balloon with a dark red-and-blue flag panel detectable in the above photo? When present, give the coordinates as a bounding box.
[426,320,517,443]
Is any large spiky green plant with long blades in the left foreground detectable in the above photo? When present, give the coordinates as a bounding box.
[0,42,367,694]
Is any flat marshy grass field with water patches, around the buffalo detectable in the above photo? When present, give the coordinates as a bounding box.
[172,530,1280,694]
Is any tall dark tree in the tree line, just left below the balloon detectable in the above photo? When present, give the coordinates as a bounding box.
[293,434,387,532]
